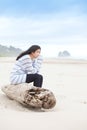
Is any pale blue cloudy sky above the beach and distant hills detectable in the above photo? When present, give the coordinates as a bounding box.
[0,0,87,57]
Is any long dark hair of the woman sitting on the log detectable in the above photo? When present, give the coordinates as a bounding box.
[16,45,41,60]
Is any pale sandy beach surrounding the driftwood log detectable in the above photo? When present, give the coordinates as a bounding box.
[0,57,87,130]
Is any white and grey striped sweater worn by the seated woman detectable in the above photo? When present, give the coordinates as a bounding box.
[10,55,43,84]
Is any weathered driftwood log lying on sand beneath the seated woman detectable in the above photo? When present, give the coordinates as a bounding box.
[2,83,56,109]
